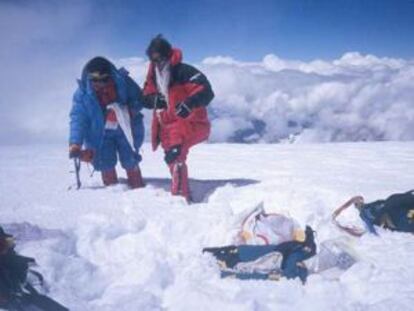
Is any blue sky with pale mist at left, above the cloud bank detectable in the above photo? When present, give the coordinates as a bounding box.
[0,0,414,143]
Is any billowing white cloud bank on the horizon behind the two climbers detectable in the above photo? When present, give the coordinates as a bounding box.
[119,51,414,142]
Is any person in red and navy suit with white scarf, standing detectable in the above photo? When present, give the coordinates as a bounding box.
[143,35,214,201]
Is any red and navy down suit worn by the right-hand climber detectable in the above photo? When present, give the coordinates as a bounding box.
[143,48,214,198]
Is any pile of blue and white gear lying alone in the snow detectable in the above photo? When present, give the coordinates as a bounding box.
[204,203,358,281]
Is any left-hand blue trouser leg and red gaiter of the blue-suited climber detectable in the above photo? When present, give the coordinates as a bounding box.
[99,130,118,186]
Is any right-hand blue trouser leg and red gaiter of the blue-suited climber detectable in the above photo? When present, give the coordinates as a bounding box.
[116,128,144,189]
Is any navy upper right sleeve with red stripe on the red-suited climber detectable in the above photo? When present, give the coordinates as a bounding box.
[178,64,214,108]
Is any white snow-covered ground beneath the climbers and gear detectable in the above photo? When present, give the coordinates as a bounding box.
[0,142,414,311]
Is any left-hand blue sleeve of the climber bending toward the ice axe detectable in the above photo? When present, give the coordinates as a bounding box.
[69,91,88,145]
